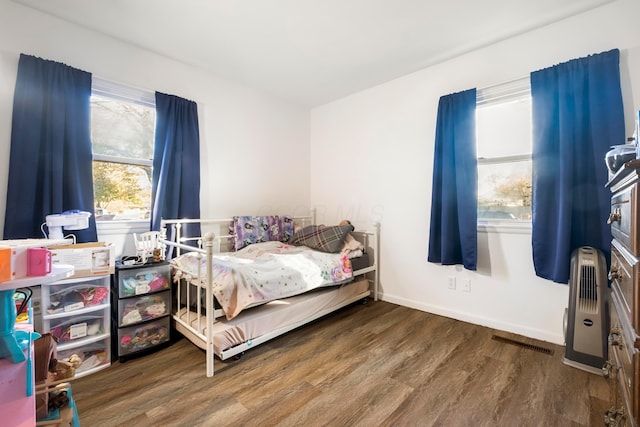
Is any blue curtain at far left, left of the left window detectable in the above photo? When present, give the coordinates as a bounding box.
[4,55,97,242]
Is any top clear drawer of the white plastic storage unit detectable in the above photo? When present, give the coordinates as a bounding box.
[42,276,109,315]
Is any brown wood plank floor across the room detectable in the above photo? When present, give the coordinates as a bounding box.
[72,301,609,427]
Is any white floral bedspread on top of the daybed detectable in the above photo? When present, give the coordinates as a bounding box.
[171,242,353,319]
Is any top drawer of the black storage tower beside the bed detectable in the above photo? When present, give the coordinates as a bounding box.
[117,264,171,298]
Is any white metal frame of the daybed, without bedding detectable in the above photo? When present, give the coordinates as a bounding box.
[159,211,380,377]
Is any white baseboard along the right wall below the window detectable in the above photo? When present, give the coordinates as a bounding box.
[380,294,564,346]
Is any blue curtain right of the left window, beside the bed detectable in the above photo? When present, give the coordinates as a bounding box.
[151,92,200,241]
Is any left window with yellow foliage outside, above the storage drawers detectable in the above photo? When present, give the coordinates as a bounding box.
[91,77,156,221]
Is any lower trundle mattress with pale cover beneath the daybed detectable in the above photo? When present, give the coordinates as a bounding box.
[176,280,369,360]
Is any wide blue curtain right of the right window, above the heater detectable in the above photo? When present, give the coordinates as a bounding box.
[531,50,625,283]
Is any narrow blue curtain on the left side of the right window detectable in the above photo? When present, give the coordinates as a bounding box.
[427,89,478,270]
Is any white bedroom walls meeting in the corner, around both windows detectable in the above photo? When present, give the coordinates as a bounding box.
[0,0,640,426]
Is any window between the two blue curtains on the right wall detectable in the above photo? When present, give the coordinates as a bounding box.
[476,78,532,221]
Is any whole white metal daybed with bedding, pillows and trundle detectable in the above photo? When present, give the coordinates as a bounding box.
[160,215,379,377]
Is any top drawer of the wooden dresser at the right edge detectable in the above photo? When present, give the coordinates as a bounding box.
[609,184,640,256]
